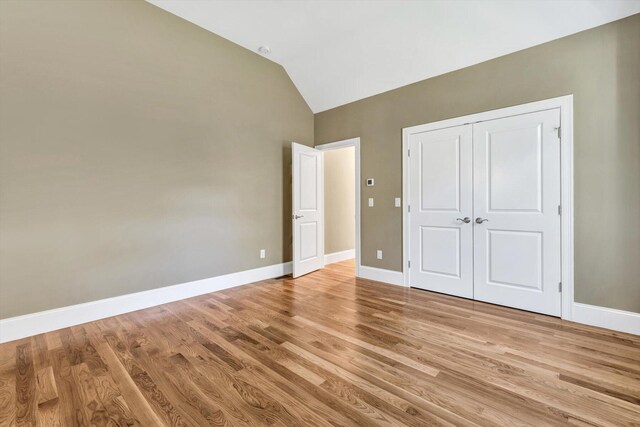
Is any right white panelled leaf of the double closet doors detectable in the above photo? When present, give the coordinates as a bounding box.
[473,109,561,316]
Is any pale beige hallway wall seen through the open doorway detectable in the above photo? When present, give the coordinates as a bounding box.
[324,147,356,254]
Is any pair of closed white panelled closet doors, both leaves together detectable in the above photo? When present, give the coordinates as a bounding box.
[409,109,561,316]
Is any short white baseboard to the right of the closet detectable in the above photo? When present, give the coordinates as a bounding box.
[572,302,640,335]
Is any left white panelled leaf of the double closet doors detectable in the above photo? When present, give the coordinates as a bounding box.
[409,125,473,298]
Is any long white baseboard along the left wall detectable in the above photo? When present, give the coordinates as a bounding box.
[0,262,291,343]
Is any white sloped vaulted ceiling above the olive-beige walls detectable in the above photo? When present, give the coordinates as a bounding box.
[148,0,640,112]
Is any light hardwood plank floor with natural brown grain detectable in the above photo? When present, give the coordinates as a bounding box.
[0,261,640,426]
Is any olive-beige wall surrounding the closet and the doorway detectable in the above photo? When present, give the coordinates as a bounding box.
[315,15,640,312]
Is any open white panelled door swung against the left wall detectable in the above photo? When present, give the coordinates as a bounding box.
[291,142,324,277]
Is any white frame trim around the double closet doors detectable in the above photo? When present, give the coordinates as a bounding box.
[402,95,574,320]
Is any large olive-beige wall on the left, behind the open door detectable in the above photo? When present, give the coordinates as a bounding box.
[0,0,313,318]
